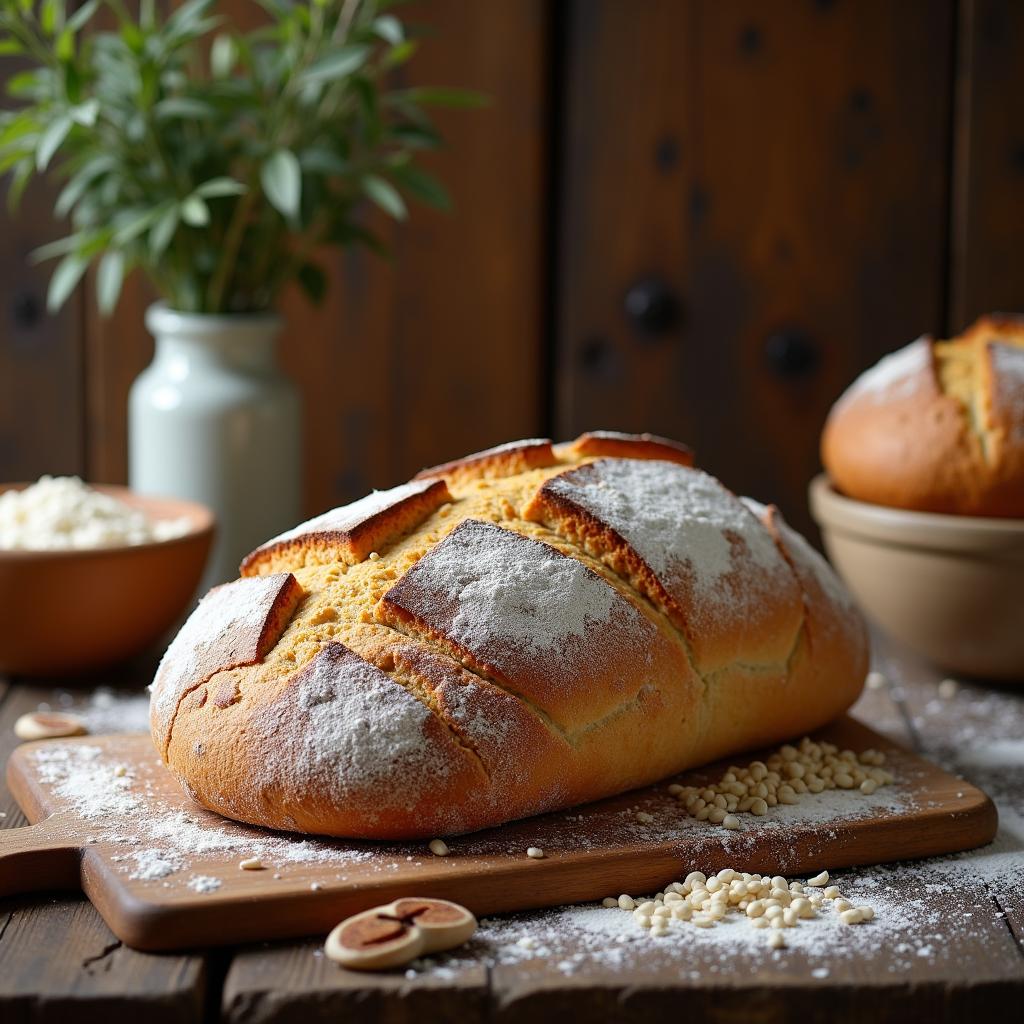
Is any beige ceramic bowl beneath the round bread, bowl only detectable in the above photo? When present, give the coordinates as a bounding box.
[810,475,1024,682]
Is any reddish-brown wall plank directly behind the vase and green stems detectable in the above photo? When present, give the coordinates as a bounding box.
[87,0,548,514]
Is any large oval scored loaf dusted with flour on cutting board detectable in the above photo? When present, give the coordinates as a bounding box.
[152,432,866,838]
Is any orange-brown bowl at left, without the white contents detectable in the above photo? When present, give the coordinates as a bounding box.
[0,483,214,676]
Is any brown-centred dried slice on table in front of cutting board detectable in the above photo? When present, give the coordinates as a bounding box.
[324,897,476,971]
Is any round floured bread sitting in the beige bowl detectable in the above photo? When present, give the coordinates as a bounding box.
[821,315,1024,517]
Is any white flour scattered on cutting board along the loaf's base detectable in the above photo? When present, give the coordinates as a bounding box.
[33,729,910,892]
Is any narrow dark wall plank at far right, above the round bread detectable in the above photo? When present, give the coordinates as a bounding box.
[948,0,1024,332]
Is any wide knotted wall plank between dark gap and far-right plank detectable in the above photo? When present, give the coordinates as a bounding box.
[556,0,952,530]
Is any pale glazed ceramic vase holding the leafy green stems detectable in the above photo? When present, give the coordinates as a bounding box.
[128,304,302,592]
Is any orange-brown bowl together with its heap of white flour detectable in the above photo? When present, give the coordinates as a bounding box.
[0,476,214,676]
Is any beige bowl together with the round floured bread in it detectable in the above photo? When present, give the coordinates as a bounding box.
[810,314,1024,681]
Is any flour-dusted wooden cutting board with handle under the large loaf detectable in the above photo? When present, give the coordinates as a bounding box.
[0,718,996,950]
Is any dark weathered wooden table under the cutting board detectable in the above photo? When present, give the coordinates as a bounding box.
[0,638,1024,1024]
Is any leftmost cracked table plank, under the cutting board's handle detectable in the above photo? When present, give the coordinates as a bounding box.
[0,683,207,1024]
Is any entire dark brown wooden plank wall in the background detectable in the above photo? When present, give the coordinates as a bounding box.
[0,0,1024,540]
